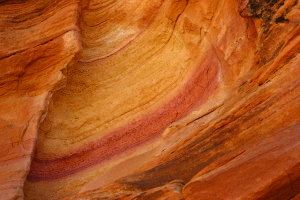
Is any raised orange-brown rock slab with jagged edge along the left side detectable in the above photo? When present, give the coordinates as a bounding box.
[0,1,81,199]
